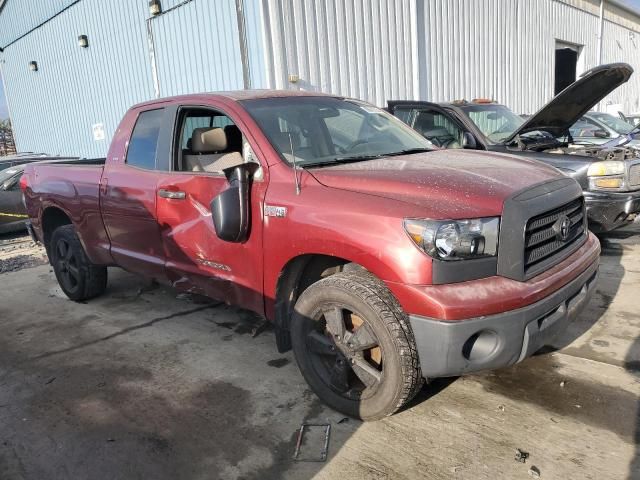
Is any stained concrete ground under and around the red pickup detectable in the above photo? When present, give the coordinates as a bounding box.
[0,224,640,480]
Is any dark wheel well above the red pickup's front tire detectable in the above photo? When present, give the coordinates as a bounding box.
[275,255,364,353]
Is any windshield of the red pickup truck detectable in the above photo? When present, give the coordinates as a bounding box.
[242,97,435,167]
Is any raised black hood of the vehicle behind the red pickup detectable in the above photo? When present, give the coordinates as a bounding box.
[503,63,633,144]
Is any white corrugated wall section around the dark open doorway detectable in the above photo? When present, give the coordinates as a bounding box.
[418,0,640,113]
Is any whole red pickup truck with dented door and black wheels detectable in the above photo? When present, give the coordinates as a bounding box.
[21,91,600,420]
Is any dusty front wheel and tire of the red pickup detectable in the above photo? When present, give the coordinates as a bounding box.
[291,271,423,420]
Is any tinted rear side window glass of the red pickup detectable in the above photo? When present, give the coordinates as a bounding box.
[126,108,164,170]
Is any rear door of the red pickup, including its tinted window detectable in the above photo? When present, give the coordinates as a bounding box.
[100,106,166,280]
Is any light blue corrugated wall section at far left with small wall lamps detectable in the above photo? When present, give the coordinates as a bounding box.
[2,0,153,156]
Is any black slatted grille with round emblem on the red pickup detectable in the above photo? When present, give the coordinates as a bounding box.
[524,198,584,273]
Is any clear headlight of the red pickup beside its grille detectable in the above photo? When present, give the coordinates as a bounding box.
[404,217,500,260]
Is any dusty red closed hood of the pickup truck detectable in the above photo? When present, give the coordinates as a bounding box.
[308,150,563,219]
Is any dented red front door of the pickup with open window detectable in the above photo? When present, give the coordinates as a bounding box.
[156,106,267,312]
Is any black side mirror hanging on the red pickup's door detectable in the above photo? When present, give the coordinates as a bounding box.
[211,163,256,243]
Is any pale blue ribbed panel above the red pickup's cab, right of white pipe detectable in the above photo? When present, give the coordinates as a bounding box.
[148,0,246,97]
